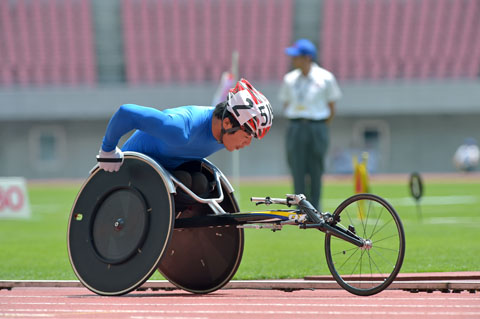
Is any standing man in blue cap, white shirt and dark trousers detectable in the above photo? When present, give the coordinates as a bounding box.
[280,39,342,210]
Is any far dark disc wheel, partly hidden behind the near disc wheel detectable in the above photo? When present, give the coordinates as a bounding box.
[159,184,244,294]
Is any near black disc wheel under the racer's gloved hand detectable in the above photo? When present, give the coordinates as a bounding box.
[67,153,175,295]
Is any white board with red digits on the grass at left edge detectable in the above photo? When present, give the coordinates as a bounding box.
[0,177,31,219]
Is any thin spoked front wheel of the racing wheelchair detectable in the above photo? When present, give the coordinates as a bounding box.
[325,194,405,296]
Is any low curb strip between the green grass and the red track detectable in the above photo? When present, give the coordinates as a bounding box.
[0,272,480,293]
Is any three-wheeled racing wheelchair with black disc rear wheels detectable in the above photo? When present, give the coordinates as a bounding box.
[67,152,405,296]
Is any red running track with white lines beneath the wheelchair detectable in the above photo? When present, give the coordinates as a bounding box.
[0,288,480,319]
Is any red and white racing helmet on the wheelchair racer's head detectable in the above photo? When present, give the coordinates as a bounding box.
[227,79,273,139]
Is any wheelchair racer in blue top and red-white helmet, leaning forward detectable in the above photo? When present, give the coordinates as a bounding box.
[97,79,273,194]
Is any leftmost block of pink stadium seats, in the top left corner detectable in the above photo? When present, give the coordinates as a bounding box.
[0,0,96,86]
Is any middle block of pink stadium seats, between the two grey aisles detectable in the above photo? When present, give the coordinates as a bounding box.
[122,0,293,85]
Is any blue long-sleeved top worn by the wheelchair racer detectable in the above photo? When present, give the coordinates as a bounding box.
[102,104,224,169]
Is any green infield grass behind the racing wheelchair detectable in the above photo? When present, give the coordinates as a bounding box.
[0,179,480,280]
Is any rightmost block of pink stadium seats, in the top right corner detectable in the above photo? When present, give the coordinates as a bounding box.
[320,0,480,80]
